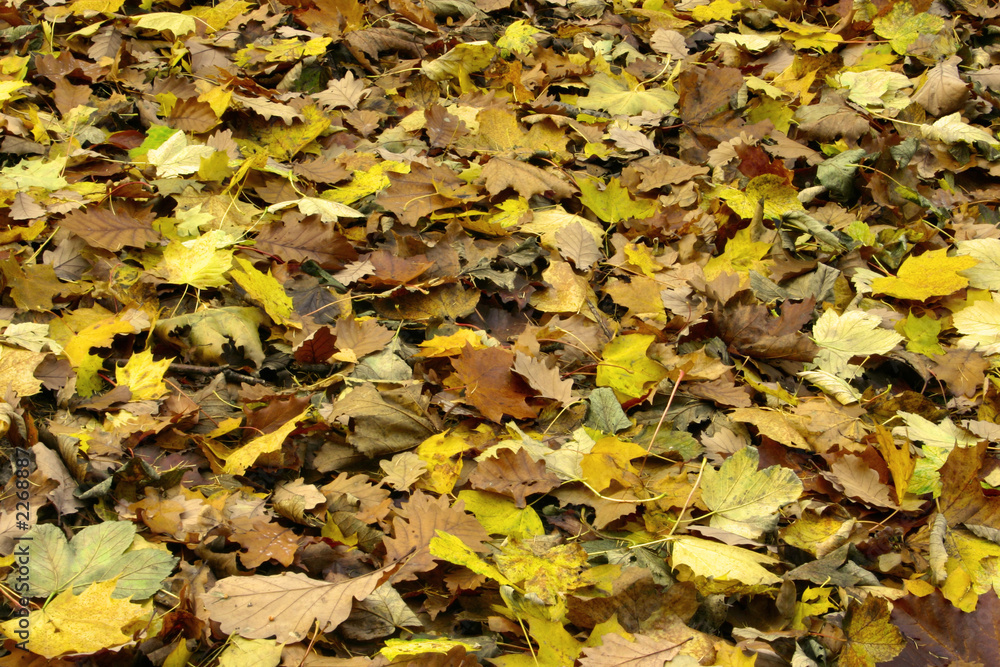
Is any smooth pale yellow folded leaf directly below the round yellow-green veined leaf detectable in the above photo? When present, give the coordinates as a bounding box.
[670,535,781,586]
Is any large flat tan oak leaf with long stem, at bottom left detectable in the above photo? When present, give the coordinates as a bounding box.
[205,564,396,644]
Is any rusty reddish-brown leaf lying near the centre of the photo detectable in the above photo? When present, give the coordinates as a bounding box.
[452,344,538,422]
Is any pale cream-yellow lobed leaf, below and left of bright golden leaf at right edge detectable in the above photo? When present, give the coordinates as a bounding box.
[812,309,903,379]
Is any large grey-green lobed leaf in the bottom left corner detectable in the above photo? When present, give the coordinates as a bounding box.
[7,521,177,599]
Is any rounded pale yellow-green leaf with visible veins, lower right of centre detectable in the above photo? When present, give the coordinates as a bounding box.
[701,447,802,539]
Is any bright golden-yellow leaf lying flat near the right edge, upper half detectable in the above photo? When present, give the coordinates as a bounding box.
[872,248,979,301]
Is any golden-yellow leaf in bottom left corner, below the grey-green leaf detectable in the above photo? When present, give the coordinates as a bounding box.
[0,579,152,658]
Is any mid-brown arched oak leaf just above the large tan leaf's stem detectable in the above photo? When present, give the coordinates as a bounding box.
[385,491,490,581]
